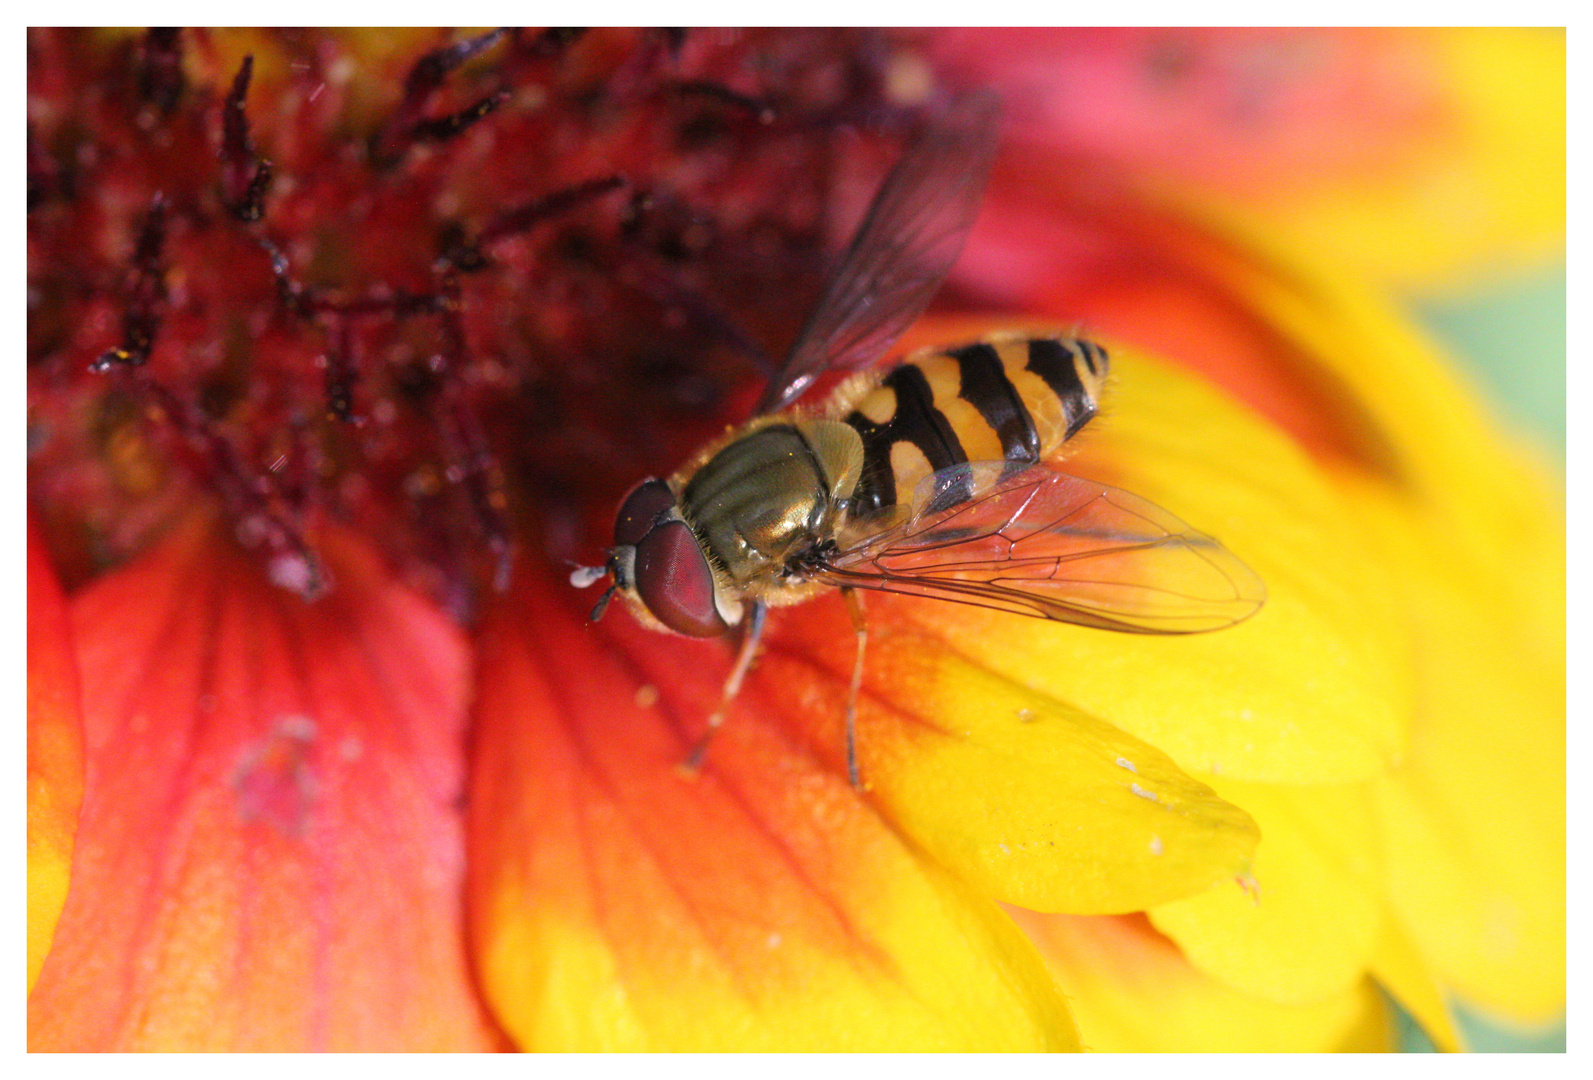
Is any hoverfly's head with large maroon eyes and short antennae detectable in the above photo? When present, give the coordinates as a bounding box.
[570,478,741,637]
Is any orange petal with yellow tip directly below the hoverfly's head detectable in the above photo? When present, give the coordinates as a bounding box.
[468,567,1077,1050]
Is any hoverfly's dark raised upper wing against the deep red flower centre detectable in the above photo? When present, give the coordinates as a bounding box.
[758,94,999,413]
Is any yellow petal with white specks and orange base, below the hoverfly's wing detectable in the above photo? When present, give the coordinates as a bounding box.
[777,608,1255,913]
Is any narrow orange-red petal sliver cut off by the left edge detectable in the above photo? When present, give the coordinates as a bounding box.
[27,513,83,991]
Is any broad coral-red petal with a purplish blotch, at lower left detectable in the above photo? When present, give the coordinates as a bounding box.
[29,521,489,1050]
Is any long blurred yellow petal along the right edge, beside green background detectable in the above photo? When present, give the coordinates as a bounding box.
[1099,236,1566,1024]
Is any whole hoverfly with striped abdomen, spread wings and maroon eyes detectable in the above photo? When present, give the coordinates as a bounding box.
[570,97,1265,787]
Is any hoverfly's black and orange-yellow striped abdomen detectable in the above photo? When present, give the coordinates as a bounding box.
[844,338,1107,518]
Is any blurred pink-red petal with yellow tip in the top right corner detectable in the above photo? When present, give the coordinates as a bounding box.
[929,27,1566,290]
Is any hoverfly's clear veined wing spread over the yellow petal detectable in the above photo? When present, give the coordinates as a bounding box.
[811,462,1266,634]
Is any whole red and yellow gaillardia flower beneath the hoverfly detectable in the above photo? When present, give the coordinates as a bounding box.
[29,30,1564,1050]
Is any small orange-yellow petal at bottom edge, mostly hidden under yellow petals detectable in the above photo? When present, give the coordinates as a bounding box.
[1013,911,1394,1053]
